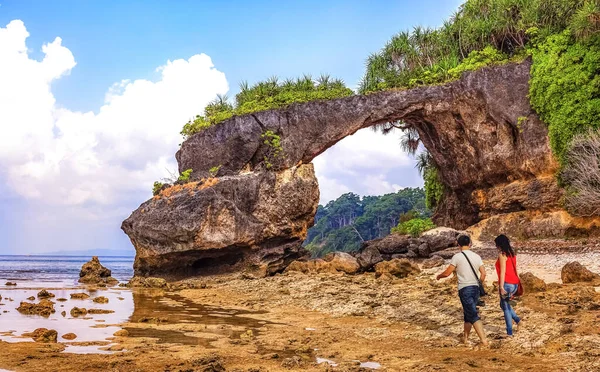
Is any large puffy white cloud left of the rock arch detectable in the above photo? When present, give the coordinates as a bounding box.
[0,20,228,209]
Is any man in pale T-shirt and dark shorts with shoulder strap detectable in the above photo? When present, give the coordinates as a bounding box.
[437,235,488,346]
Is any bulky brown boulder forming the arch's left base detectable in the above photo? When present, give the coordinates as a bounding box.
[122,164,319,278]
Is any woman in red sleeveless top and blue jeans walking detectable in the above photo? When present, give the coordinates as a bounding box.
[495,235,521,336]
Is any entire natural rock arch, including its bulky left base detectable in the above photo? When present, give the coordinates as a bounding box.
[122,61,580,276]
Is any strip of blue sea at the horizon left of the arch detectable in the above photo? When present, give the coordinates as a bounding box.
[0,255,133,287]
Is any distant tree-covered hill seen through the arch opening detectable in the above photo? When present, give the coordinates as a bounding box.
[304,188,431,257]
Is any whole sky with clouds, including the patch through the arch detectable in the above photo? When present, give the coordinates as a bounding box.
[0,0,460,253]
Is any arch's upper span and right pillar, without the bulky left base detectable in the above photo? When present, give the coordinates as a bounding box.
[177,61,562,228]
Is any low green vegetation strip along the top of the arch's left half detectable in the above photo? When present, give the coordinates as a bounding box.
[181,75,354,139]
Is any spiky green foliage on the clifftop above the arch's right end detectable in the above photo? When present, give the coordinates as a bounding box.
[359,0,588,93]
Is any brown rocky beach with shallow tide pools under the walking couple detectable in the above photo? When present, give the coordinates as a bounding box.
[0,253,600,371]
